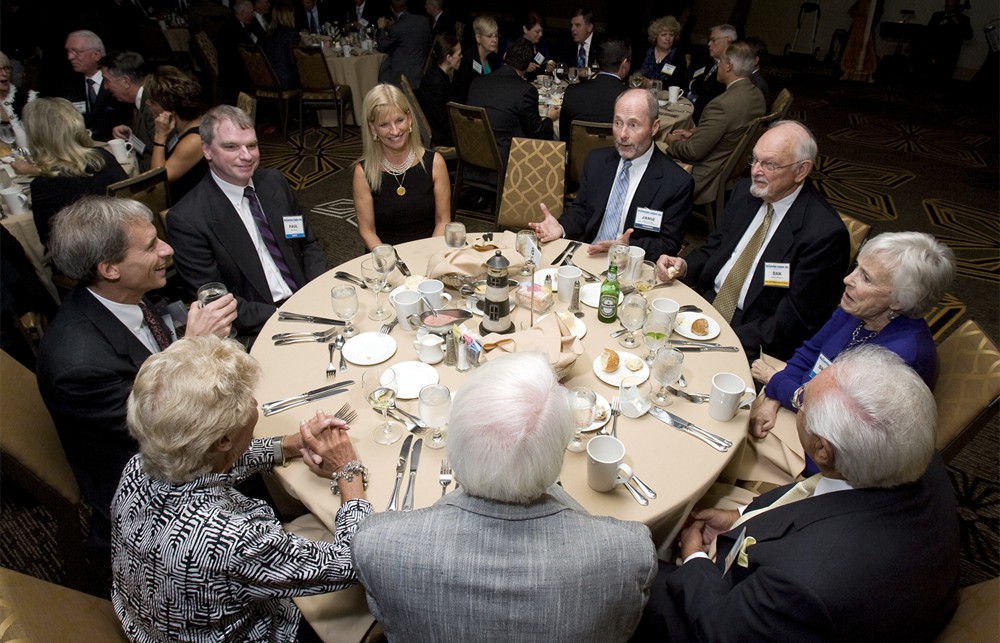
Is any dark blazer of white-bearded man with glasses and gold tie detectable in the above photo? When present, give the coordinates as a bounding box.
[688,179,851,360]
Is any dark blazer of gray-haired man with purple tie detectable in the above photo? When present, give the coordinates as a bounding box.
[167,169,327,335]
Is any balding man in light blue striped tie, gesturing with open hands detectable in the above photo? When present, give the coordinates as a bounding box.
[529,89,694,259]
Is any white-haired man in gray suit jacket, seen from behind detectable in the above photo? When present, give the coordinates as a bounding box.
[352,353,656,642]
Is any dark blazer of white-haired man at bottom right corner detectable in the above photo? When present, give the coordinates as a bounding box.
[633,454,959,642]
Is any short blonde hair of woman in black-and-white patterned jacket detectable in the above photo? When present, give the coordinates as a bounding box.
[128,335,261,484]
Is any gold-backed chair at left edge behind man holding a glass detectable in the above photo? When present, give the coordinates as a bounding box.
[0,351,97,592]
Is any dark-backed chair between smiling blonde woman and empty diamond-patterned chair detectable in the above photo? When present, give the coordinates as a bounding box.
[448,102,504,224]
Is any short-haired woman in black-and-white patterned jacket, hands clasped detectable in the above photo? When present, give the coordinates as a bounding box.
[111,336,372,641]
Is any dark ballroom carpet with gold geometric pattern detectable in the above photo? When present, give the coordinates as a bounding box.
[0,66,1000,586]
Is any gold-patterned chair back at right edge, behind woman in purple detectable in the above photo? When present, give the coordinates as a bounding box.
[934,319,1000,462]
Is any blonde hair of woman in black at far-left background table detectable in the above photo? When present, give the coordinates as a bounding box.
[22,98,104,177]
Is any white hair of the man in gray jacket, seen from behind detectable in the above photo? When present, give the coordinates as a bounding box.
[445,353,573,504]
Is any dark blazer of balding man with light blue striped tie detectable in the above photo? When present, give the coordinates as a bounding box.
[559,146,694,261]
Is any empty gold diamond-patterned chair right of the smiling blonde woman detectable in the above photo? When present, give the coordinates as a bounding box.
[497,136,566,231]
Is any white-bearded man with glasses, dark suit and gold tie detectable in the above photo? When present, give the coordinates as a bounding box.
[660,121,850,361]
